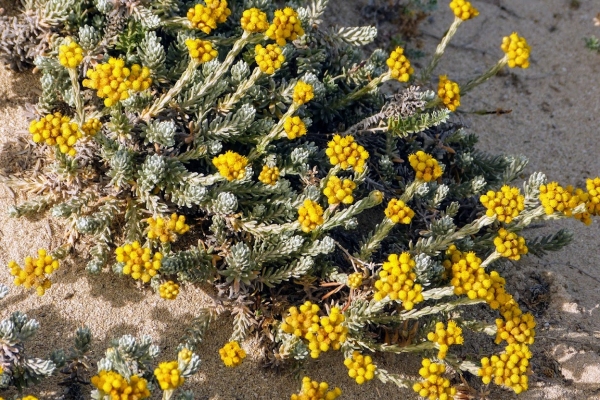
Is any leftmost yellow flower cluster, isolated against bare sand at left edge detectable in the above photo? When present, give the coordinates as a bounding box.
[8,249,59,296]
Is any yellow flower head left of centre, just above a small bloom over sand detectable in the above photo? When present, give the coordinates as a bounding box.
[115,240,163,283]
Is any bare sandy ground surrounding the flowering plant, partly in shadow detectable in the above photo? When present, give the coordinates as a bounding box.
[0,0,600,400]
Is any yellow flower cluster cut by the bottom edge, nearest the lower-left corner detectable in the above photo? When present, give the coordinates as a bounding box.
[91,370,150,400]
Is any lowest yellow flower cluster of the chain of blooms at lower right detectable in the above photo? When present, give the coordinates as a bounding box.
[479,344,532,394]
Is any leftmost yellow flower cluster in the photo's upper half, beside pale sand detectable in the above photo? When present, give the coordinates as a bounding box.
[29,112,83,157]
